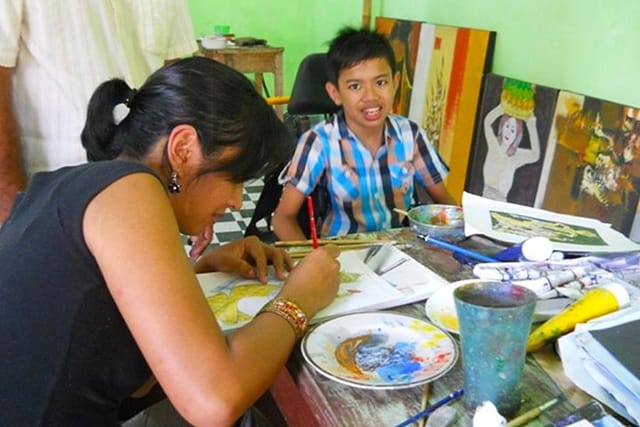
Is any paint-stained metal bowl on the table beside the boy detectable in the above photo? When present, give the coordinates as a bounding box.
[408,204,464,242]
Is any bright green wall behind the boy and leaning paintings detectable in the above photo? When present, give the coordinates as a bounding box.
[189,0,640,107]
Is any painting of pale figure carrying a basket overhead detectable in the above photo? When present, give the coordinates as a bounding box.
[466,74,558,206]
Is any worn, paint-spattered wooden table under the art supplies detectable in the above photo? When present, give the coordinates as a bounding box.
[258,229,591,427]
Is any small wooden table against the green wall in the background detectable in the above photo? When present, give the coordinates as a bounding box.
[198,46,284,118]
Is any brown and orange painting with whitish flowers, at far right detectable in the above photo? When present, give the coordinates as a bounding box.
[536,91,640,235]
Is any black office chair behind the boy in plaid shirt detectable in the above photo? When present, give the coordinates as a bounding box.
[244,53,338,243]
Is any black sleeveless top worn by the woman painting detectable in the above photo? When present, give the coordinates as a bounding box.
[0,161,165,427]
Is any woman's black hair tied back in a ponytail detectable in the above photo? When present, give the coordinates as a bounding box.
[82,57,295,183]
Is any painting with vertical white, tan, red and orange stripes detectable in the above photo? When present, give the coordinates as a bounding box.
[409,23,495,201]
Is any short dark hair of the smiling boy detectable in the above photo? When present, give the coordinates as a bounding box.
[327,27,396,86]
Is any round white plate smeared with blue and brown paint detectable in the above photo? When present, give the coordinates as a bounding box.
[301,312,458,389]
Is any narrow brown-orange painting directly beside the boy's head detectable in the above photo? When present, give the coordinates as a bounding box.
[376,17,421,116]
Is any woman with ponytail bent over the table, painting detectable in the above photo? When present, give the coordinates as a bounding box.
[0,57,339,426]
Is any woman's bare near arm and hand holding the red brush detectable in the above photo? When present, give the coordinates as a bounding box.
[83,174,339,425]
